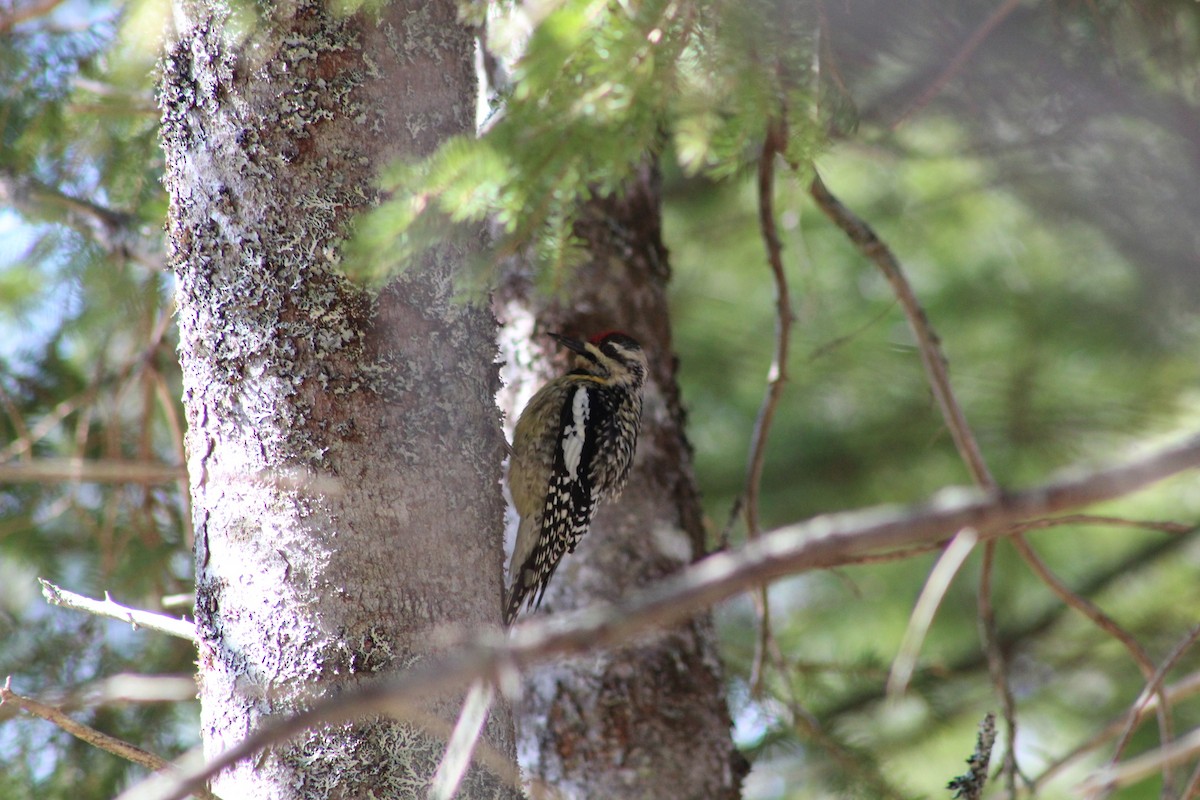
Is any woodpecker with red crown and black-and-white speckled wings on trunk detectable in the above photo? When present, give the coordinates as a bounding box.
[504,331,647,625]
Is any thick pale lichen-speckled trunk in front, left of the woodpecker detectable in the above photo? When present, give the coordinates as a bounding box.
[161,0,514,799]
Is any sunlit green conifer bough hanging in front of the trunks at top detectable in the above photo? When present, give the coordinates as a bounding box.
[350,0,824,284]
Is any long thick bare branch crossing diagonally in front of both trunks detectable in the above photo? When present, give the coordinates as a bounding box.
[112,435,1200,800]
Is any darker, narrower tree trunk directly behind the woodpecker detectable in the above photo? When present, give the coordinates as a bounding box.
[498,167,748,800]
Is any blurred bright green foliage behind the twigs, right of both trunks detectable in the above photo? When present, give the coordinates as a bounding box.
[666,97,1200,798]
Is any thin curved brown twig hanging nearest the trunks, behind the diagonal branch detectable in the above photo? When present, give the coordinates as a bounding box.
[743,118,794,693]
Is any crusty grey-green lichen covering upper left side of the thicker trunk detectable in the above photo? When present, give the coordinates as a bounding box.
[160,1,373,468]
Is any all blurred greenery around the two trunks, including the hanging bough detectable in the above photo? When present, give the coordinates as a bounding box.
[0,0,1200,800]
